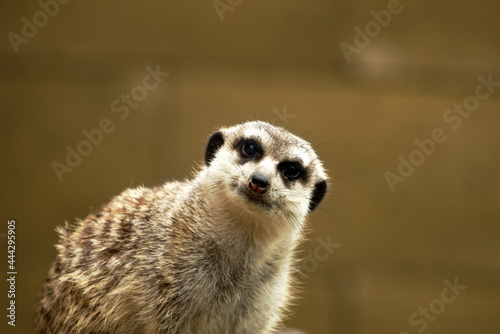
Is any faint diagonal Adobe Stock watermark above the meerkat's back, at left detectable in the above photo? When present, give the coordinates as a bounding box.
[51,64,170,182]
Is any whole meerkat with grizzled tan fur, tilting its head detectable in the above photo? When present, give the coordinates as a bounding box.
[36,121,328,334]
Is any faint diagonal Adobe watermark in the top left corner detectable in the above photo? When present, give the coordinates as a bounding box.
[7,0,71,53]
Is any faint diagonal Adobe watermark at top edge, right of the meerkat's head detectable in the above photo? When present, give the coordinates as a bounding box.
[339,0,412,64]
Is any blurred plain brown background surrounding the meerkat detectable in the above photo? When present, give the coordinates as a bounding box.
[0,0,500,334]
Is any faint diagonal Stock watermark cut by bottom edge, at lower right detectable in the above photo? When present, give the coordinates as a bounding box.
[399,277,468,334]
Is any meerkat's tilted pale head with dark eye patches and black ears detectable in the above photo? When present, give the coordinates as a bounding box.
[205,121,327,219]
